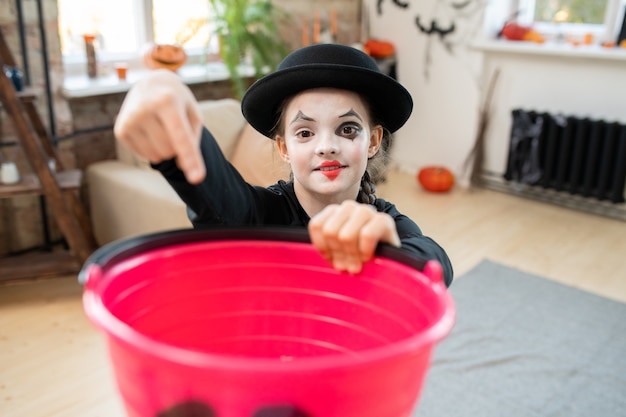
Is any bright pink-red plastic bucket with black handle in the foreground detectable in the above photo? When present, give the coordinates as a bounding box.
[80,229,454,417]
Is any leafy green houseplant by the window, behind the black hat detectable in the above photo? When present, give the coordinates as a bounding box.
[209,0,288,99]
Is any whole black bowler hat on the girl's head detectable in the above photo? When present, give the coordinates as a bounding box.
[241,44,413,137]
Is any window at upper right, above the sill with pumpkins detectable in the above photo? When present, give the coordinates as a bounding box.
[513,0,626,42]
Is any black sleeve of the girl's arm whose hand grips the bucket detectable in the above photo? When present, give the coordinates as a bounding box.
[376,199,454,286]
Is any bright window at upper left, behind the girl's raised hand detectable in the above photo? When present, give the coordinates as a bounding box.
[58,0,215,64]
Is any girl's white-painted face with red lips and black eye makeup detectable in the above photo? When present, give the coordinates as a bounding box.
[276,88,382,215]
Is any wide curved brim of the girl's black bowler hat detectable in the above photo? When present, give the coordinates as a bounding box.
[241,64,413,137]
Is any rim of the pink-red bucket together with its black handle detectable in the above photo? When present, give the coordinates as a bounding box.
[79,227,455,416]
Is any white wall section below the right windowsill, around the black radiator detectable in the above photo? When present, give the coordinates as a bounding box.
[484,46,626,173]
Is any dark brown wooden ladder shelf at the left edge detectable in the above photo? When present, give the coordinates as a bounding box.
[0,26,96,281]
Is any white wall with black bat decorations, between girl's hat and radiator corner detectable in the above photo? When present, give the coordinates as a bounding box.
[364,0,483,180]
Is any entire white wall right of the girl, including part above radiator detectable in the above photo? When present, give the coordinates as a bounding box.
[364,0,626,185]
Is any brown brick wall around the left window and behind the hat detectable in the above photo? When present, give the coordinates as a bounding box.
[0,0,361,255]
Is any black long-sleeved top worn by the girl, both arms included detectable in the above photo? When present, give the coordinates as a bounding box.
[154,129,453,285]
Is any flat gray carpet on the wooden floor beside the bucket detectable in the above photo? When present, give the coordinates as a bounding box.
[413,261,626,417]
